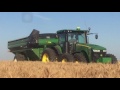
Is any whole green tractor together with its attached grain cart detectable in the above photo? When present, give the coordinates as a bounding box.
[8,28,117,63]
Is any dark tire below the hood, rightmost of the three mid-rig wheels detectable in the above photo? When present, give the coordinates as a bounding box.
[74,52,88,63]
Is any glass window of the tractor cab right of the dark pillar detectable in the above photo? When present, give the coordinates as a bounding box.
[68,32,86,43]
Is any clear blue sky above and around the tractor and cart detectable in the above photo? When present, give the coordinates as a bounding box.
[0,12,120,60]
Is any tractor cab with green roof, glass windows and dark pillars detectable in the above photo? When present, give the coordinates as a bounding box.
[57,28,89,53]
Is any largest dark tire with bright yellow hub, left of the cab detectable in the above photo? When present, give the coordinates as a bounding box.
[42,48,57,62]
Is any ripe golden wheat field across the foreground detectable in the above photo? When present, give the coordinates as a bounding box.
[0,61,120,78]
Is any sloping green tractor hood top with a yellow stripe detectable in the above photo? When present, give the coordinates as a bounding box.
[78,43,106,50]
